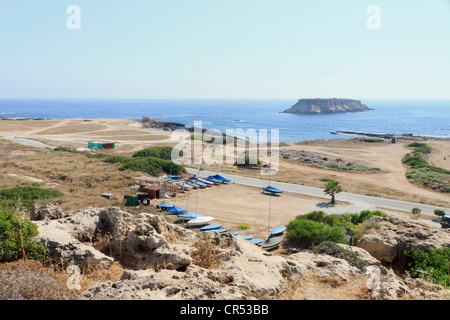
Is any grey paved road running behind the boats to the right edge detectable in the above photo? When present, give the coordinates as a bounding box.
[187,168,450,218]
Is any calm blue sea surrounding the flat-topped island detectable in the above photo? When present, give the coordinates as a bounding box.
[0,99,450,142]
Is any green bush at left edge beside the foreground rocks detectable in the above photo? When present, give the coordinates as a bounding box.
[0,211,46,262]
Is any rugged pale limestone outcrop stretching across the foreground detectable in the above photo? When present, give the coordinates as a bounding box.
[36,207,446,300]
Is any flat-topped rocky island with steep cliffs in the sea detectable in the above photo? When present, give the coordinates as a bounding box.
[282,98,373,114]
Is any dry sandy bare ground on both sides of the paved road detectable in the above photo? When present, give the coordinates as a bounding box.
[0,119,450,231]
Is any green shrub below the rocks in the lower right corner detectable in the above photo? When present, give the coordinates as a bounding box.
[405,248,450,288]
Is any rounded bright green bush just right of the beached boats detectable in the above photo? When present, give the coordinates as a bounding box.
[286,220,348,249]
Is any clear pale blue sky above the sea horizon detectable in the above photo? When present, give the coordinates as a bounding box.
[0,0,450,99]
